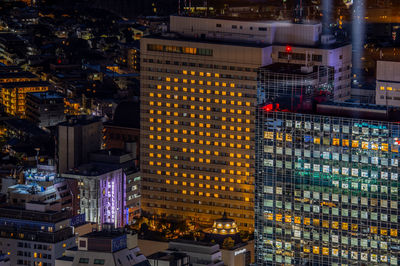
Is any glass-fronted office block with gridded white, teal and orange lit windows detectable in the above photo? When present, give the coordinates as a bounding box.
[255,103,400,265]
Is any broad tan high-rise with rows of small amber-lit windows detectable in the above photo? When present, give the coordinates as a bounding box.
[140,16,351,230]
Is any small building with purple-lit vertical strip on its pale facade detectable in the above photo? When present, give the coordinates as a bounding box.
[63,164,127,228]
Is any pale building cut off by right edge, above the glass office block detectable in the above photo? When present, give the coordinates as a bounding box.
[375,61,400,107]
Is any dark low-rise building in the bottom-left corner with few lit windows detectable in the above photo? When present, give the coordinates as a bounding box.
[0,205,75,266]
